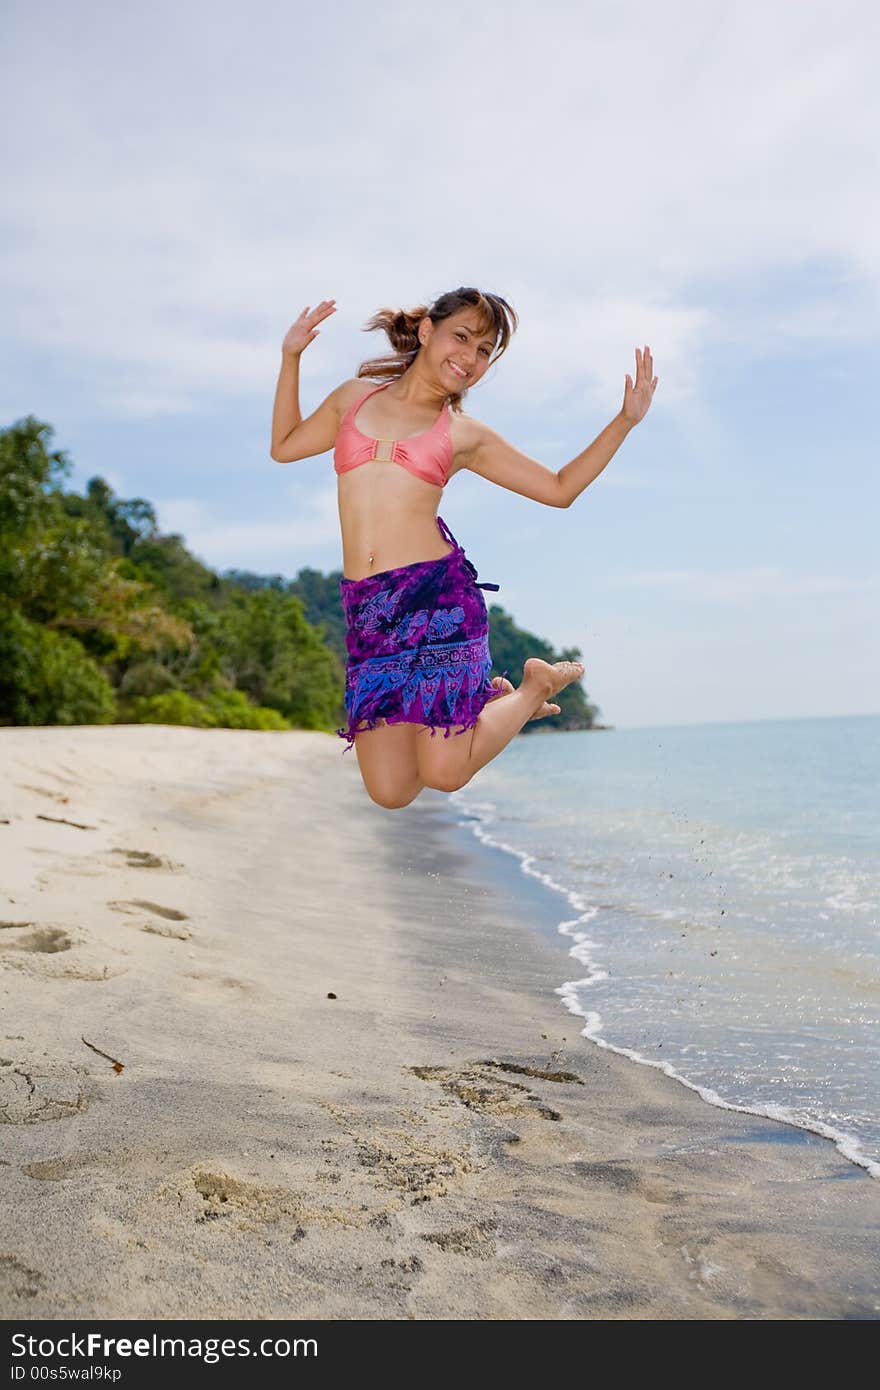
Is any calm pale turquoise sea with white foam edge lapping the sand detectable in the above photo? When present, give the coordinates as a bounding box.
[450,714,880,1177]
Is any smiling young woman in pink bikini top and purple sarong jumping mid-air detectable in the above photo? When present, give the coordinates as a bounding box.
[270,286,658,809]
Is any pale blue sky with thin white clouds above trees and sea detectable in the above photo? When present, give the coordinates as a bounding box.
[0,0,880,728]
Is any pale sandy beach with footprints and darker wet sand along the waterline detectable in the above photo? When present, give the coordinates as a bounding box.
[0,724,880,1319]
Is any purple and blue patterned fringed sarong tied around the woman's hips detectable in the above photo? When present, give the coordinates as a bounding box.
[336,517,506,753]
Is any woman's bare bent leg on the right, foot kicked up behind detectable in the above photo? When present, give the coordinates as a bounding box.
[416,656,584,791]
